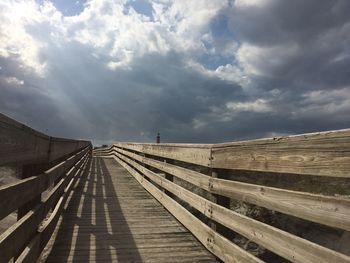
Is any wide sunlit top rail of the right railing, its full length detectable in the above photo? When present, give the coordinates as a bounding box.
[104,129,350,177]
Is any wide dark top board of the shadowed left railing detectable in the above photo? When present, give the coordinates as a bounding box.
[0,113,91,165]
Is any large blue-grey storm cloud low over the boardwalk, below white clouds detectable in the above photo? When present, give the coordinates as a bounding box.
[1,35,245,142]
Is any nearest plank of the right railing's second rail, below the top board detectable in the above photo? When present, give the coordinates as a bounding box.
[210,179,350,231]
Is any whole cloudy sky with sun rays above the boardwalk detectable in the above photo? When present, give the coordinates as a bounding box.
[0,0,350,145]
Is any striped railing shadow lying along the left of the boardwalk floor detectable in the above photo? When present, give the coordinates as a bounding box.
[47,158,142,262]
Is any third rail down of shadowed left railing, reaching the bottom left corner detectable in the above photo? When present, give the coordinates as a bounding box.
[0,152,89,262]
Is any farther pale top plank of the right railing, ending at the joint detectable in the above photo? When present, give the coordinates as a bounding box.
[113,143,211,167]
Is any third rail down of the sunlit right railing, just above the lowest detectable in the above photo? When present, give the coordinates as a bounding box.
[117,153,350,263]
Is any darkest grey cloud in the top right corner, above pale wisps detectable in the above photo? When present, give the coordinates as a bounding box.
[228,0,350,46]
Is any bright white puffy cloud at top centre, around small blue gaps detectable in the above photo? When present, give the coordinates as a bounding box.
[59,0,227,69]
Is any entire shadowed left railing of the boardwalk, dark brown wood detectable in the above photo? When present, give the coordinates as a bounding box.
[0,114,91,262]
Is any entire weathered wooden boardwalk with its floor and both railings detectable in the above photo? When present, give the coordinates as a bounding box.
[0,114,350,263]
